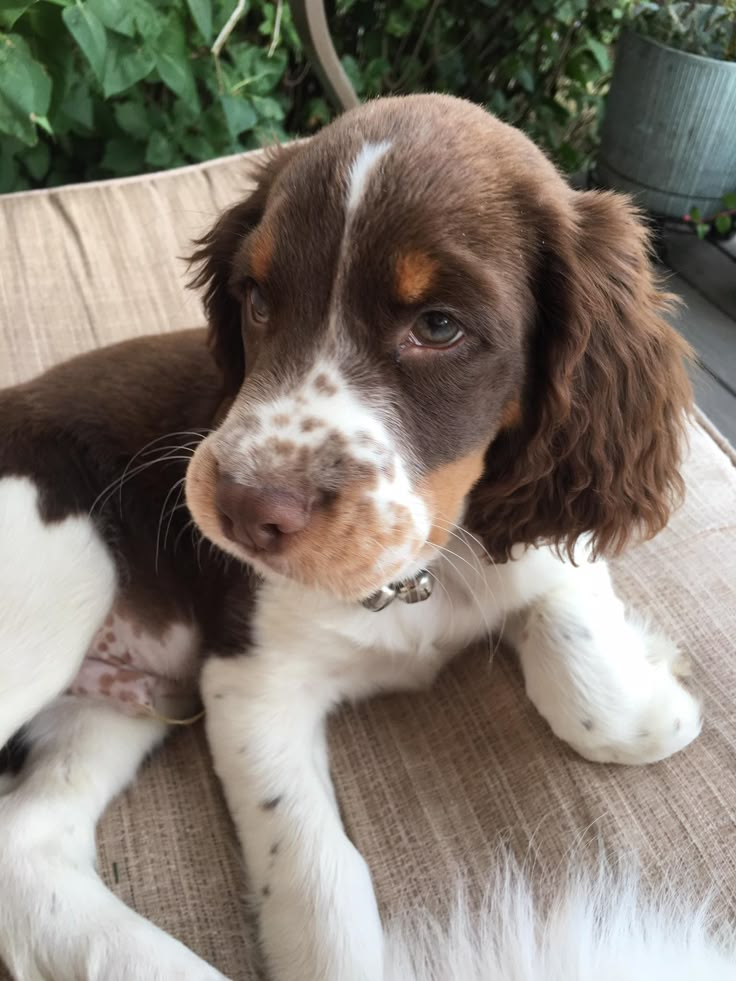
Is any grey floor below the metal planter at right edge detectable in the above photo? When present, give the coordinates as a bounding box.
[665,230,736,444]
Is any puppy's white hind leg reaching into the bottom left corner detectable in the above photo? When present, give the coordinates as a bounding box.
[0,695,222,981]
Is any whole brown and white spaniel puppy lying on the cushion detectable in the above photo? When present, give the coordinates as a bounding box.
[0,96,700,981]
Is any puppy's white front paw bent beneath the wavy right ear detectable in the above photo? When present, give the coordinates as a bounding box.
[505,562,701,763]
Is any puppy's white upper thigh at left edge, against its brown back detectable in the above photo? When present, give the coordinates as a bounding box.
[0,477,115,749]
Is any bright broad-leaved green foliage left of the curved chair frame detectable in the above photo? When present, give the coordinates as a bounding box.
[0,0,298,190]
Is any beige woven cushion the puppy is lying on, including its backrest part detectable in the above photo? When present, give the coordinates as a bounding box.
[0,158,736,981]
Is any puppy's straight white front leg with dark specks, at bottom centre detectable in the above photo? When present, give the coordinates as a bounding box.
[202,643,383,981]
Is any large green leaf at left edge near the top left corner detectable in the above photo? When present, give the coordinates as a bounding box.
[0,34,51,146]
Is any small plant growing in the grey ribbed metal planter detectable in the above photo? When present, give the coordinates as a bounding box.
[629,0,736,61]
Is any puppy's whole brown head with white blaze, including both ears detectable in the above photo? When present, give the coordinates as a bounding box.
[187,96,689,599]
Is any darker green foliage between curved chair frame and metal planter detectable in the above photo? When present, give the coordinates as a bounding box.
[330,0,630,170]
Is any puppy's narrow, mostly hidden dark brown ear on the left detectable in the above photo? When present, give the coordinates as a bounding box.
[189,144,299,395]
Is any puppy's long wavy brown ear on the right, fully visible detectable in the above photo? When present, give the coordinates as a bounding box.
[468,192,692,557]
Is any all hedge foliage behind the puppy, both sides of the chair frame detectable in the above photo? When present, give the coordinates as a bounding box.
[0,0,630,191]
